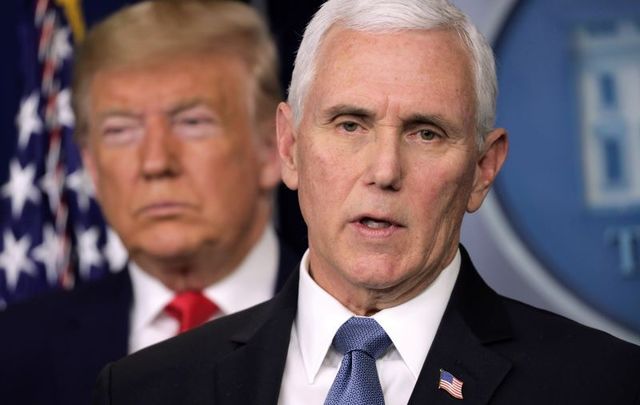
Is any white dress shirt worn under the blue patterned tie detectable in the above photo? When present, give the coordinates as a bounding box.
[278,251,460,405]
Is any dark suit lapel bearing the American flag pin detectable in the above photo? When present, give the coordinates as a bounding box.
[409,247,511,405]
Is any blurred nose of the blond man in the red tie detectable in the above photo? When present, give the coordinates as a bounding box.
[140,117,180,179]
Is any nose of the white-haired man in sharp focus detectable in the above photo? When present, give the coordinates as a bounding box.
[366,129,404,191]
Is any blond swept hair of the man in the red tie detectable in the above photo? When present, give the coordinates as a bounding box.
[72,0,282,144]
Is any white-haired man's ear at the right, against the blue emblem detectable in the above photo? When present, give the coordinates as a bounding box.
[467,128,509,212]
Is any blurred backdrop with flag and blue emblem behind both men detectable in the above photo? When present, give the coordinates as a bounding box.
[0,0,640,343]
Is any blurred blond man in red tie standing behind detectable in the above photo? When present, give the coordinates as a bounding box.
[0,0,297,405]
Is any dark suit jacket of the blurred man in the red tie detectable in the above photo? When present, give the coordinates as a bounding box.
[0,243,299,405]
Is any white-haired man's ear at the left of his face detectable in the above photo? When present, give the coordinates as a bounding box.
[276,103,298,190]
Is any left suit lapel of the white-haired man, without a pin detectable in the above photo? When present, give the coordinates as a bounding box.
[214,271,298,405]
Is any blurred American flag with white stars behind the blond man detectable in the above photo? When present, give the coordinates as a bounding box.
[0,0,126,309]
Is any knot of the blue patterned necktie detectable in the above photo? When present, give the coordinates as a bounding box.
[333,317,391,359]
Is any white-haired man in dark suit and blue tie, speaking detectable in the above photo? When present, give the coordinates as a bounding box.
[94,0,640,405]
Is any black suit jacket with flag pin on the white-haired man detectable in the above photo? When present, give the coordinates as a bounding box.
[94,246,640,405]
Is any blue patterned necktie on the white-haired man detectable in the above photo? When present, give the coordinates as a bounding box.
[324,317,391,405]
